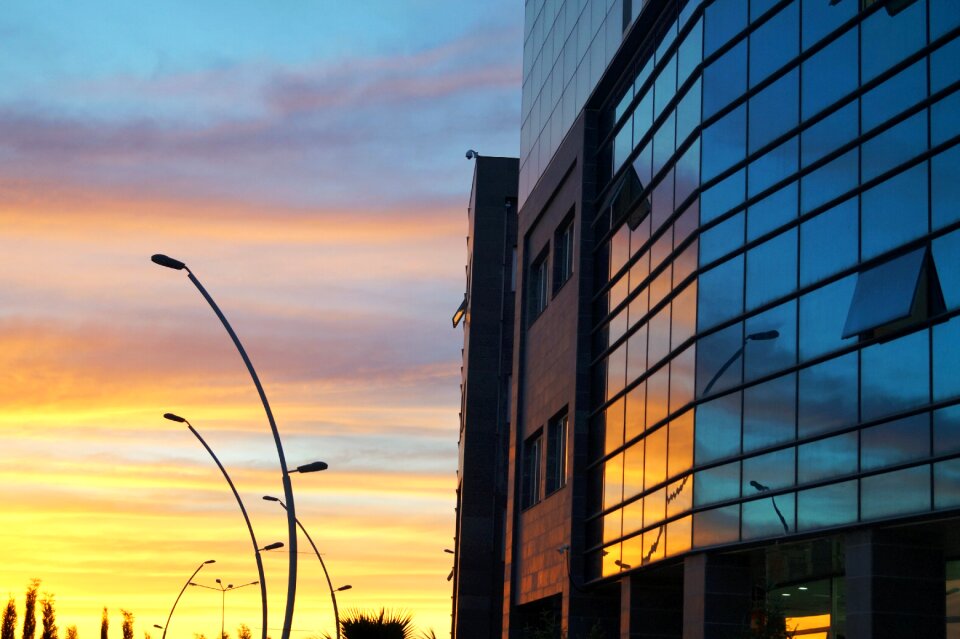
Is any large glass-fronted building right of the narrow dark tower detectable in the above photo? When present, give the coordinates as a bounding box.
[470,0,960,639]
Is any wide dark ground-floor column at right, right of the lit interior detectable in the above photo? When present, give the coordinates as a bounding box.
[846,530,946,639]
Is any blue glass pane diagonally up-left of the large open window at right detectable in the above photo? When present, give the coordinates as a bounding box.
[800,197,860,286]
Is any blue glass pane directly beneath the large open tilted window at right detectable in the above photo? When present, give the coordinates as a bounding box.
[860,331,930,421]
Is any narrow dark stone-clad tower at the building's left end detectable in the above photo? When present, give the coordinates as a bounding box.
[451,156,519,638]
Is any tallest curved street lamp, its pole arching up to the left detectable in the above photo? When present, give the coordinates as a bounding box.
[150,253,297,639]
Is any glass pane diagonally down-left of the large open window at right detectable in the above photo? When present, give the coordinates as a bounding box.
[797,353,857,437]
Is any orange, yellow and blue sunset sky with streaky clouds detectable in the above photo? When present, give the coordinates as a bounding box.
[0,5,523,639]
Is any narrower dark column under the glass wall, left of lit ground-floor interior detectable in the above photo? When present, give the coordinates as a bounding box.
[683,554,752,639]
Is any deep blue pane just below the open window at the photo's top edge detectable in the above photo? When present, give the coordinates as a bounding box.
[861,2,927,82]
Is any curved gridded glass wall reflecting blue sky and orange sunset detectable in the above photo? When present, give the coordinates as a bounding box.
[588,0,960,577]
